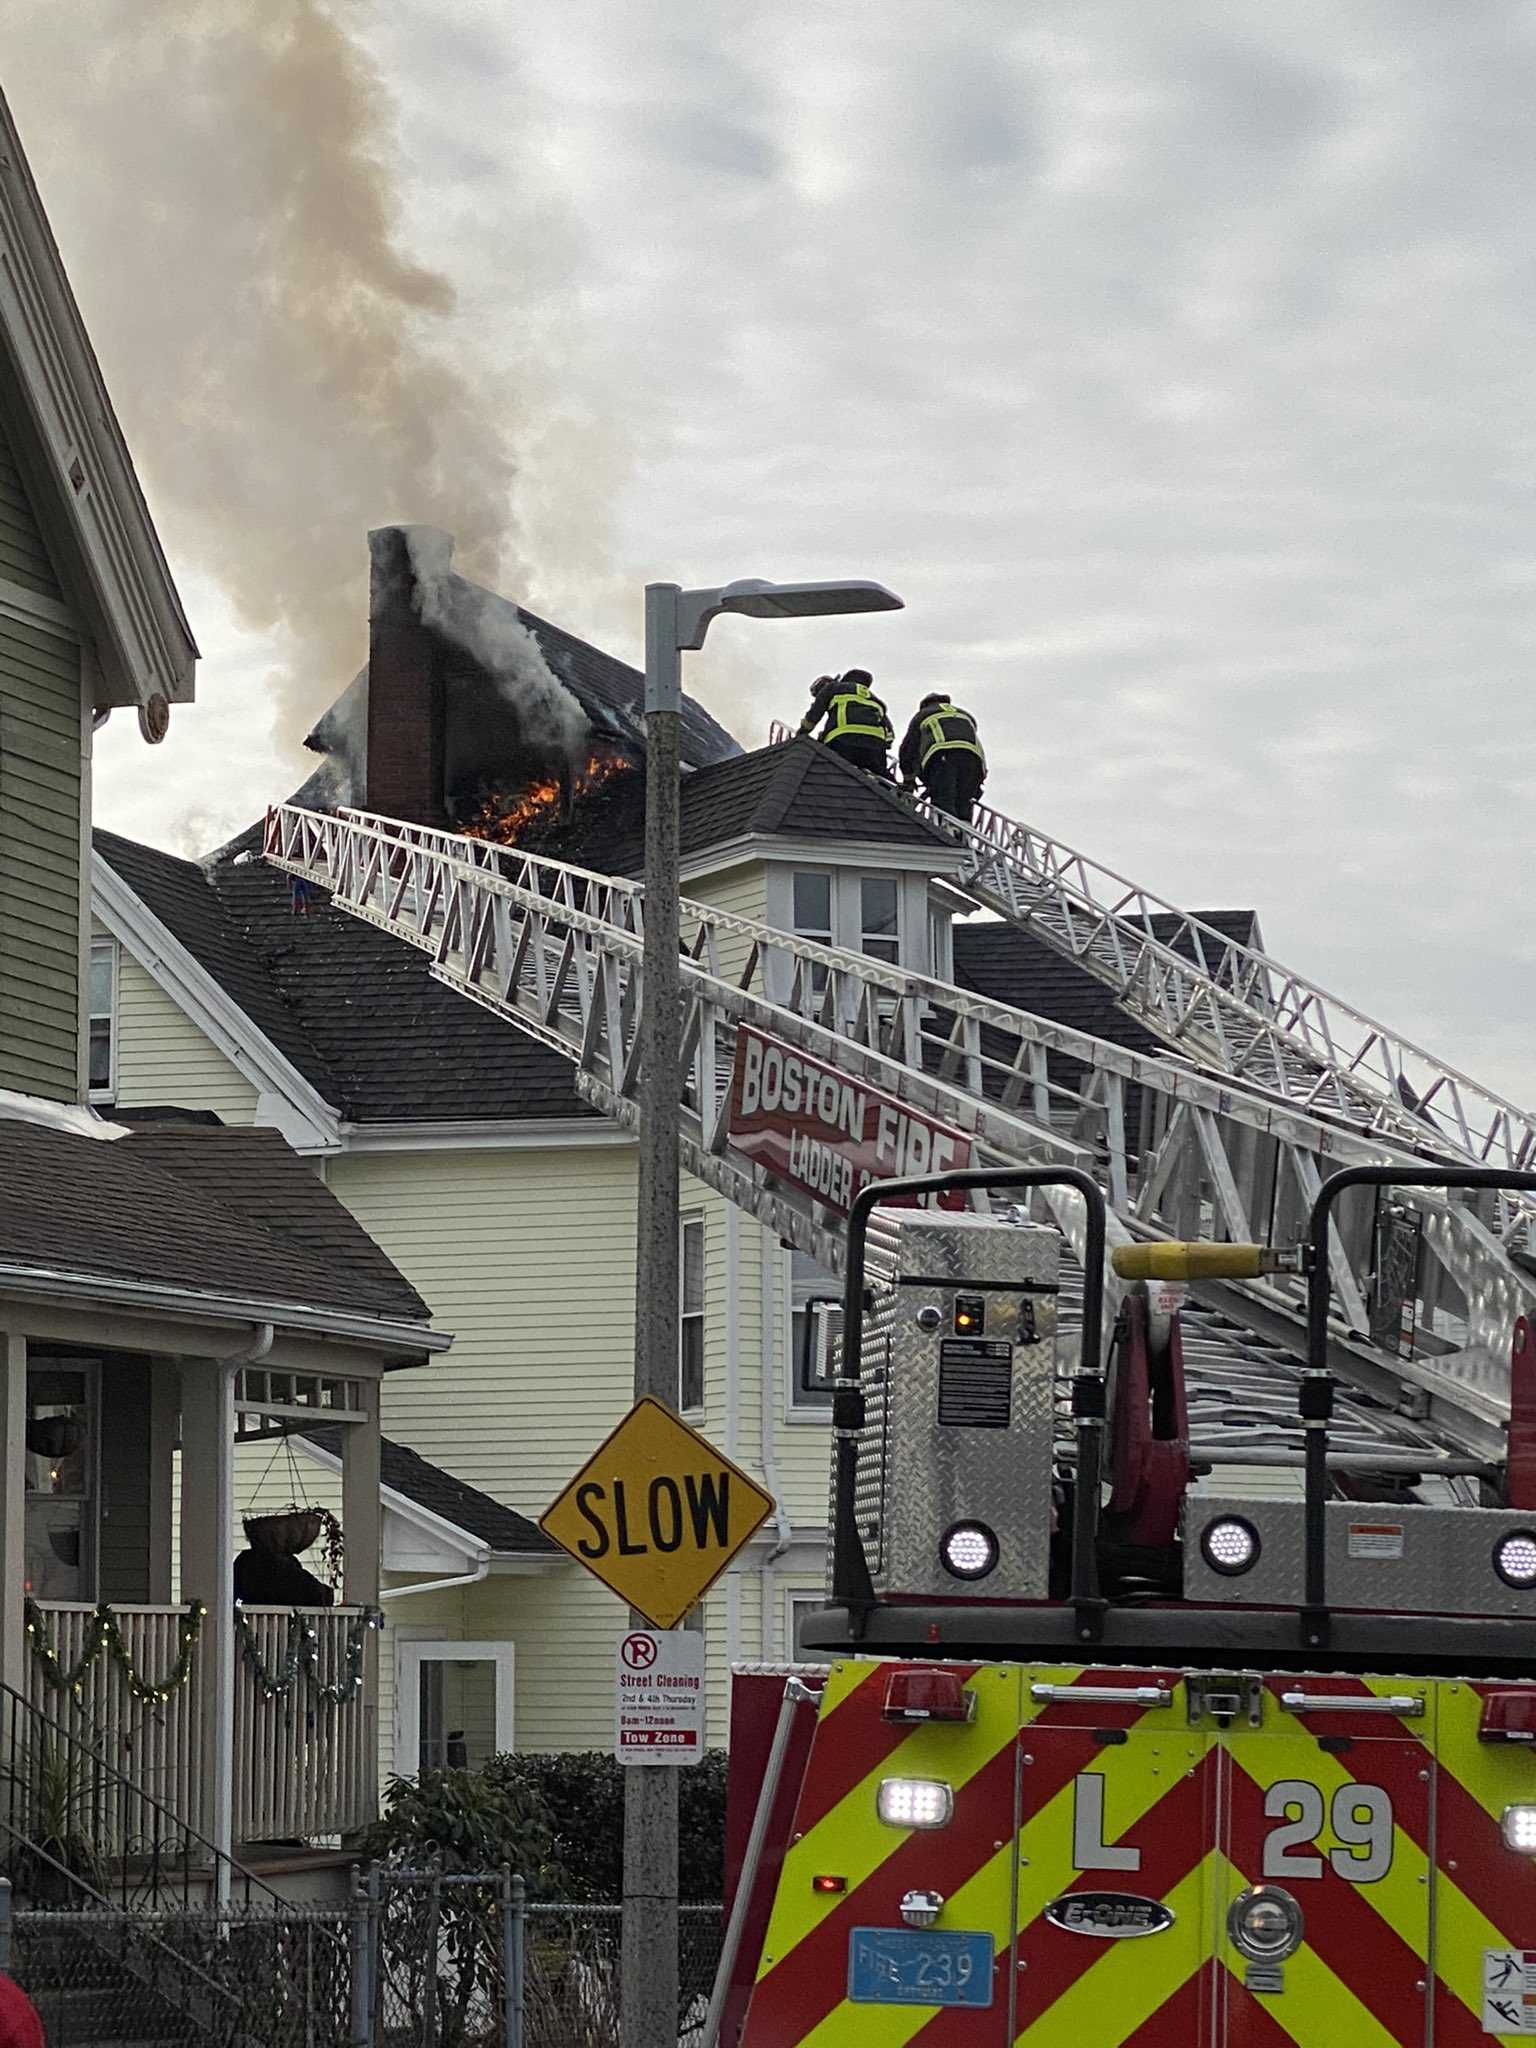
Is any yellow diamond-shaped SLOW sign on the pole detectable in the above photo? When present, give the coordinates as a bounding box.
[539,1395,774,1628]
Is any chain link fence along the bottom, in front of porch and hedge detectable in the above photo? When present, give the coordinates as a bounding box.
[0,1866,721,2048]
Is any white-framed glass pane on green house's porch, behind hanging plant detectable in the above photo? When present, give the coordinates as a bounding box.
[27,1358,96,1599]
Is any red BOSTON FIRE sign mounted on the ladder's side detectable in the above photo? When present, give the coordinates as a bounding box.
[729,1024,971,1217]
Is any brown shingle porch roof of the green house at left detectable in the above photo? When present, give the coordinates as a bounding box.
[0,1118,430,1323]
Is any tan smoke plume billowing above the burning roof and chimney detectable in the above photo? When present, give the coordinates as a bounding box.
[0,0,602,745]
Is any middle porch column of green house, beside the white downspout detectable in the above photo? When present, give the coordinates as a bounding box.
[182,1358,236,1855]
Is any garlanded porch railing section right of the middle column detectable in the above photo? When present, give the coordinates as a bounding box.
[233,1606,379,1841]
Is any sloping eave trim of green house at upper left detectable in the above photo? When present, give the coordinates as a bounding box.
[0,100,197,705]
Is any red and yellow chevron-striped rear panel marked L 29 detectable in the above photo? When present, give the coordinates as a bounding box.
[741,1663,1536,2048]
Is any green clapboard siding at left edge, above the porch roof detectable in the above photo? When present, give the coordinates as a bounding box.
[0,598,84,1102]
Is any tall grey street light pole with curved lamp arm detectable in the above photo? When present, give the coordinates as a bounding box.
[618,578,901,2048]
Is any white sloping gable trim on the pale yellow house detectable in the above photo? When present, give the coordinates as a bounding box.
[90,852,340,1151]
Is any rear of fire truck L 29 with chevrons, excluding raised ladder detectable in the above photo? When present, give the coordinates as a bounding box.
[709,1167,1536,2048]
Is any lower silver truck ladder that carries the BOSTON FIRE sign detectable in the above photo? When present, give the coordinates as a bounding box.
[264,805,1536,1460]
